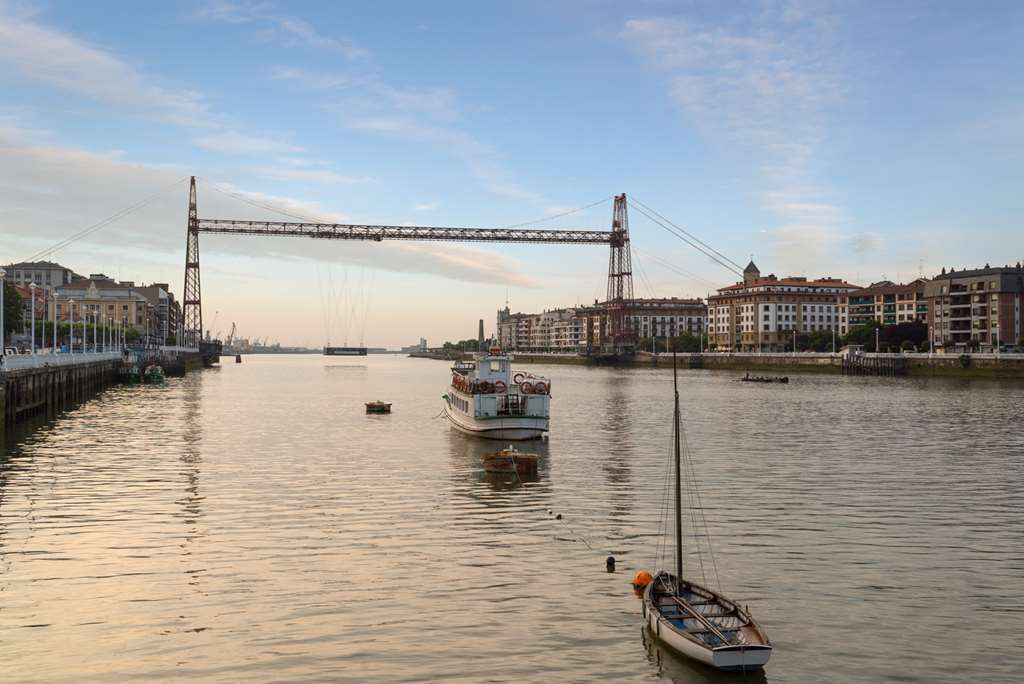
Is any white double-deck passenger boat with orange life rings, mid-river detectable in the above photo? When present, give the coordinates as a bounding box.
[444,347,551,440]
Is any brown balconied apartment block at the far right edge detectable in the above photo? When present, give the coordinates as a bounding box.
[925,262,1024,350]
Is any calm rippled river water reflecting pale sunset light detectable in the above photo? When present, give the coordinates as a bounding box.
[0,356,1024,682]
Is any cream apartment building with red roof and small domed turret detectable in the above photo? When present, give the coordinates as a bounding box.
[708,261,861,351]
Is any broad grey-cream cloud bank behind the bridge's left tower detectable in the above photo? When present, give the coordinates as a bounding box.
[0,141,539,287]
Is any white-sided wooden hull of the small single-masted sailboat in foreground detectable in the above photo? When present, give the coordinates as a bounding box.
[643,575,772,672]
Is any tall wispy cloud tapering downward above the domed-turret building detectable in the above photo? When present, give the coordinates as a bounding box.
[622,2,844,266]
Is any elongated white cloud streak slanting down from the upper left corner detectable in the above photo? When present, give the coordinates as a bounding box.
[0,4,212,127]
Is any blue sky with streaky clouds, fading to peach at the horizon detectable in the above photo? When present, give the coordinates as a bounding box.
[0,0,1024,347]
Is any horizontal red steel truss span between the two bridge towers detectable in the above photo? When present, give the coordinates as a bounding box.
[197,218,615,245]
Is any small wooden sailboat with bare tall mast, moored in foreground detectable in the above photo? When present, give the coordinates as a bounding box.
[638,354,772,671]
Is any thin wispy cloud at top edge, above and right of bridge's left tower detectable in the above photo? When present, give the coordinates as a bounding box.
[197,0,371,59]
